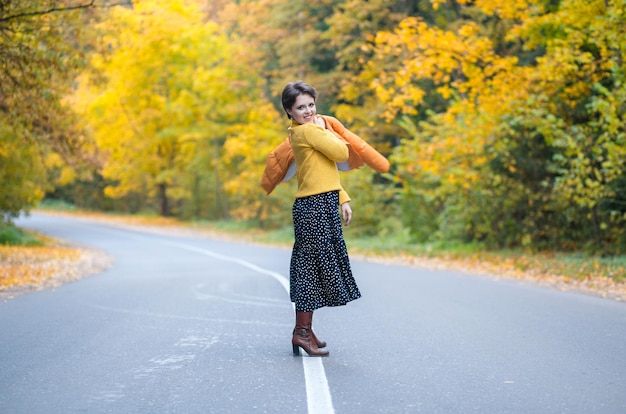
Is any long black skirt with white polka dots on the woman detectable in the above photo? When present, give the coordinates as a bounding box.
[289,191,361,312]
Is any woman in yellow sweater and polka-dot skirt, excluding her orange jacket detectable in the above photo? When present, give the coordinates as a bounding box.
[282,81,361,356]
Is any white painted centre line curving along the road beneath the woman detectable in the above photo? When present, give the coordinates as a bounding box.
[166,242,335,414]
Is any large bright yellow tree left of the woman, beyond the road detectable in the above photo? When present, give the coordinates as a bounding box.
[72,0,279,218]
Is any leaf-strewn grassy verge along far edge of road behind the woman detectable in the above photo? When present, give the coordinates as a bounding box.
[7,205,626,300]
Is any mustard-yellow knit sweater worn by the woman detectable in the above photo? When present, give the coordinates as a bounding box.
[289,120,350,204]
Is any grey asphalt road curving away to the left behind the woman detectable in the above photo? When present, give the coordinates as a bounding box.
[0,215,626,414]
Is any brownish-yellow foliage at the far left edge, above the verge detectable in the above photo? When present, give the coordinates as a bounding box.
[0,0,94,219]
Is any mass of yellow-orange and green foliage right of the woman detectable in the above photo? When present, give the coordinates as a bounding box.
[361,1,626,252]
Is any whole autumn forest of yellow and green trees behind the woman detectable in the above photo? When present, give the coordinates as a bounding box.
[0,0,626,255]
